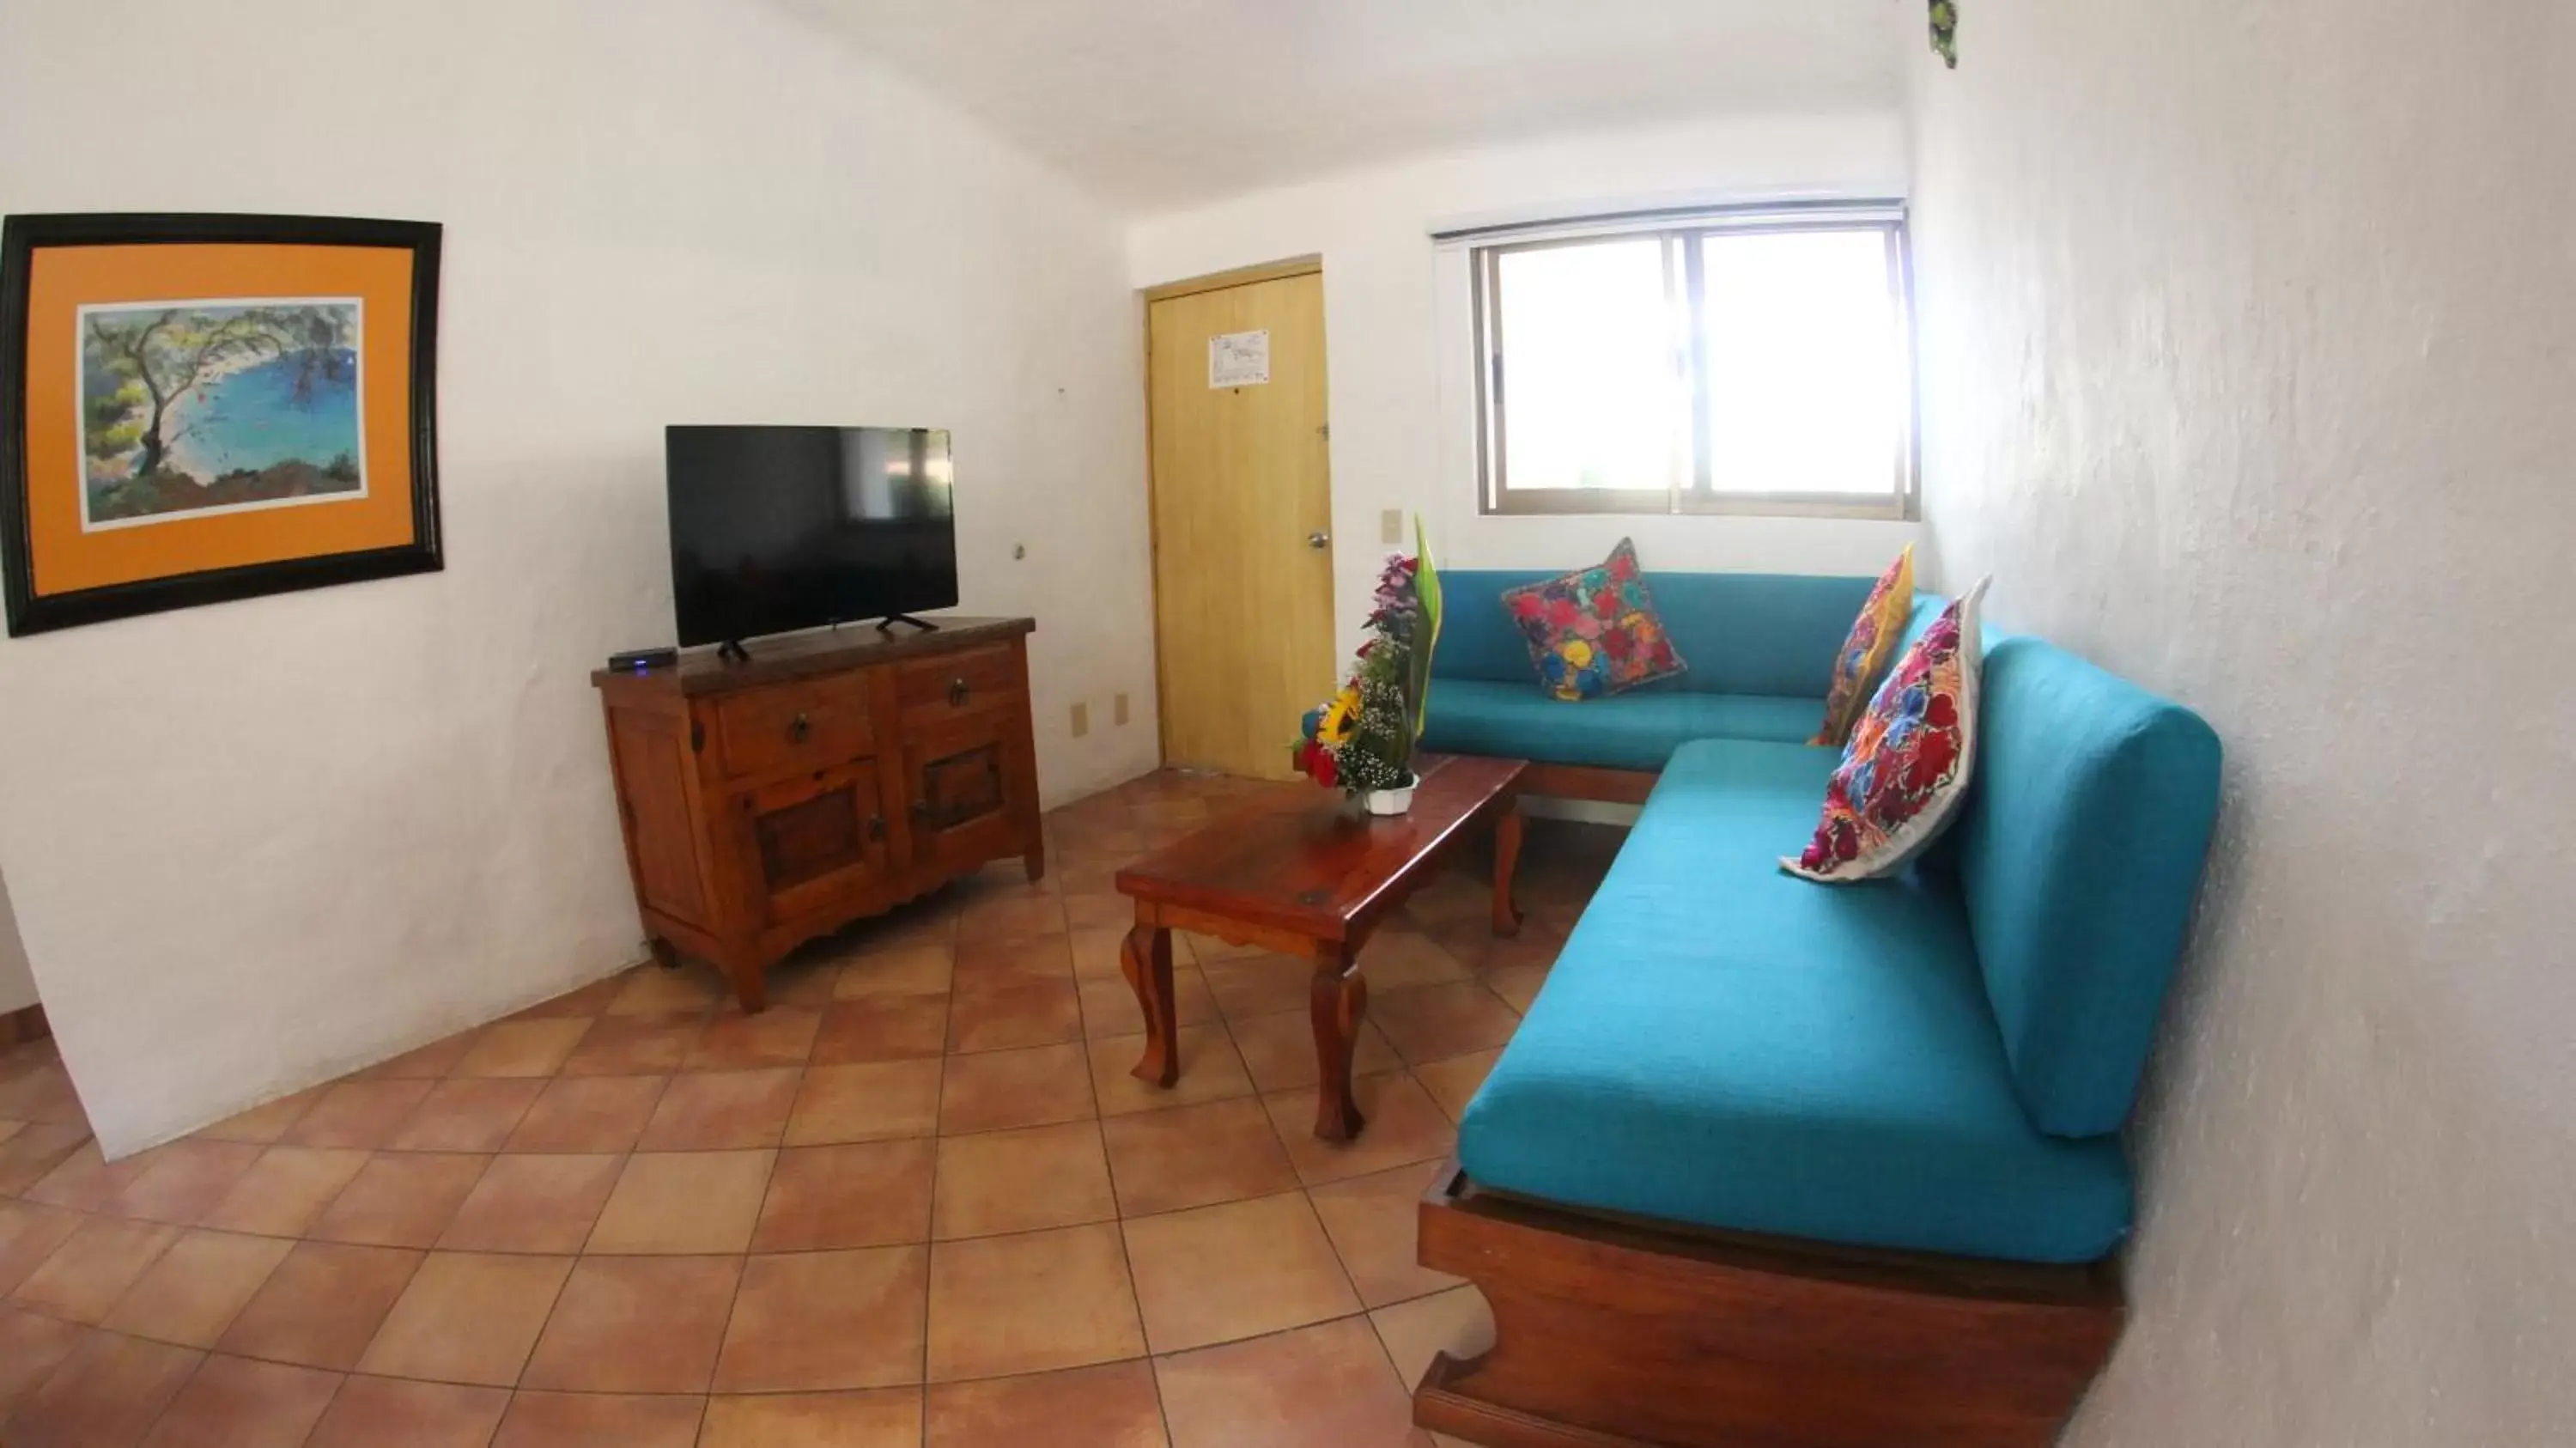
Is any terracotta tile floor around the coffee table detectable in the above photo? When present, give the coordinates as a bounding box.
[0,773,1615,1448]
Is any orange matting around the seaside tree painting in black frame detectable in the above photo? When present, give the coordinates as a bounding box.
[26,245,415,598]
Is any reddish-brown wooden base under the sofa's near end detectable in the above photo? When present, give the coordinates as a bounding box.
[1414,1162,2123,1448]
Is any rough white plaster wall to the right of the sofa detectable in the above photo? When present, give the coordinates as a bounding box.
[1914,0,2576,1448]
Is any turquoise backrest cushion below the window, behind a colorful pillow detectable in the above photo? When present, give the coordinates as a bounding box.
[1432,569,1886,701]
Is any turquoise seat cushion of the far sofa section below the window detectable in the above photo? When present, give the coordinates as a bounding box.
[1422,678,1824,773]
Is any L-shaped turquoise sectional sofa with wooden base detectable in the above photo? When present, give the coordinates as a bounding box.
[1417,572,2218,1445]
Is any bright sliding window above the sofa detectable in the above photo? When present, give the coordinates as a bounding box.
[1471,209,1914,518]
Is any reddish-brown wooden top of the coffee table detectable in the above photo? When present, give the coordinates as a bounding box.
[1118,755,1528,940]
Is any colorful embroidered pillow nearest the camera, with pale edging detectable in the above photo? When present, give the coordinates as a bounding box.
[1780,580,1989,884]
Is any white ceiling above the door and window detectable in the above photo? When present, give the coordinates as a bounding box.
[781,0,1901,209]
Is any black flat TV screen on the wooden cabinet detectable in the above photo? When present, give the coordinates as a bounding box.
[665,428,958,647]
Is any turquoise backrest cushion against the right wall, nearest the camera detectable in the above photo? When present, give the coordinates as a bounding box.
[1953,636,2218,1136]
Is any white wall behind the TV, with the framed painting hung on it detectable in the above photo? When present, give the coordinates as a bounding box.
[0,0,1154,1152]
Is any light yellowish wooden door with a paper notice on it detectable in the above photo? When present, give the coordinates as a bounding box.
[1146,268,1334,778]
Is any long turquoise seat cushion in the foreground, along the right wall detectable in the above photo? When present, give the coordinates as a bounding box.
[1458,739,2130,1262]
